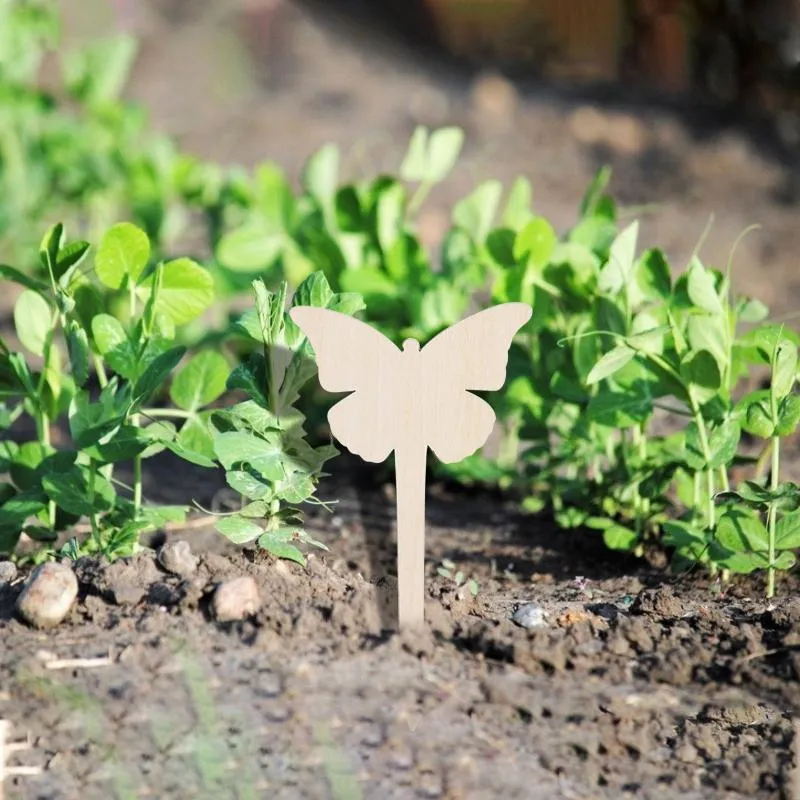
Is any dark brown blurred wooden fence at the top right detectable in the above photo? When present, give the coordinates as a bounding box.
[418,0,800,111]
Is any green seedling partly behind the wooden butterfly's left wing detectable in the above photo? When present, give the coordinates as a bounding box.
[211,273,363,564]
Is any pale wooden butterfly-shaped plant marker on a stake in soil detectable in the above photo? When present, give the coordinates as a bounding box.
[289,303,531,628]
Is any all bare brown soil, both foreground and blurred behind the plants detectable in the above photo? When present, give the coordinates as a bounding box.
[0,0,800,800]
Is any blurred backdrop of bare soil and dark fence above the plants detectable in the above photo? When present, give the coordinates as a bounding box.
[21,0,800,313]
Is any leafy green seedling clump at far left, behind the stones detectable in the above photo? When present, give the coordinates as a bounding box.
[0,223,217,558]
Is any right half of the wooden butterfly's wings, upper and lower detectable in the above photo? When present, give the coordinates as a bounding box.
[420,303,532,463]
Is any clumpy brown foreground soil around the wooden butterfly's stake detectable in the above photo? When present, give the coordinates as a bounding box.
[0,472,800,800]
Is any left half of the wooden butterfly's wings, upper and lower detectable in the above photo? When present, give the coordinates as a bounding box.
[289,306,403,462]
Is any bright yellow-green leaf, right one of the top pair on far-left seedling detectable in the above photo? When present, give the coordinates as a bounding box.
[136,258,214,325]
